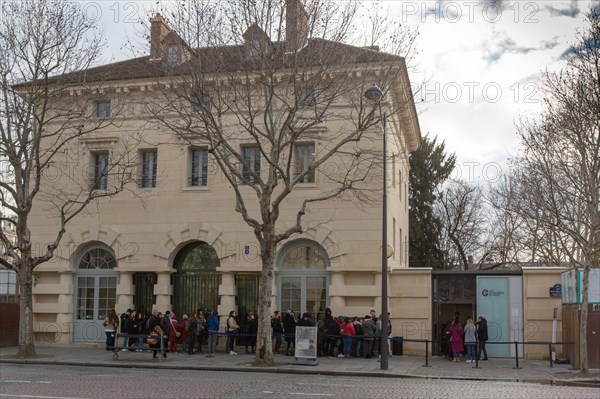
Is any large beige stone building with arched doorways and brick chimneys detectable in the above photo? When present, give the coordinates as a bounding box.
[30,0,421,343]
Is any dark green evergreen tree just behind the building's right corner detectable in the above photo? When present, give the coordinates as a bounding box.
[409,136,456,268]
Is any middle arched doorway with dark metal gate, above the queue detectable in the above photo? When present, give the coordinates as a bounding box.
[171,241,221,317]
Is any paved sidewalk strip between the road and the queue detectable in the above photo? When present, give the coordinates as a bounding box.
[0,344,600,386]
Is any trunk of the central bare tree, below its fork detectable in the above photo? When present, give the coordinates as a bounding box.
[256,244,275,366]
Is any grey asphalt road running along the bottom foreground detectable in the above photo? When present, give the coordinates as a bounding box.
[0,363,600,399]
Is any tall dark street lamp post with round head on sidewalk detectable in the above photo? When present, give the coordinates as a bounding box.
[365,85,388,370]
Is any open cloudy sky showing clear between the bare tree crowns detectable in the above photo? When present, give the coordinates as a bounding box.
[95,0,600,182]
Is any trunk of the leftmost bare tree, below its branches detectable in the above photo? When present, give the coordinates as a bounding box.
[17,260,36,358]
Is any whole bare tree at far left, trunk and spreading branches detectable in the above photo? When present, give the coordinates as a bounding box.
[0,0,138,357]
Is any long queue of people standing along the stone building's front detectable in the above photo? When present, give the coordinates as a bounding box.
[104,308,392,359]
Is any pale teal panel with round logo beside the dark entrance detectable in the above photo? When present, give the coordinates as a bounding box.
[476,276,512,357]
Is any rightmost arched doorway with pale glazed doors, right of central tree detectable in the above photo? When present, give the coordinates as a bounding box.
[277,240,330,317]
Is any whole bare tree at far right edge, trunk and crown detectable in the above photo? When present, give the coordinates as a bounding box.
[514,7,600,373]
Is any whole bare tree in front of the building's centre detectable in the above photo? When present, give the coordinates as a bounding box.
[151,0,420,364]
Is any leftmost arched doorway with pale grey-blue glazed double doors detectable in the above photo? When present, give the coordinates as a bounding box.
[73,243,119,341]
